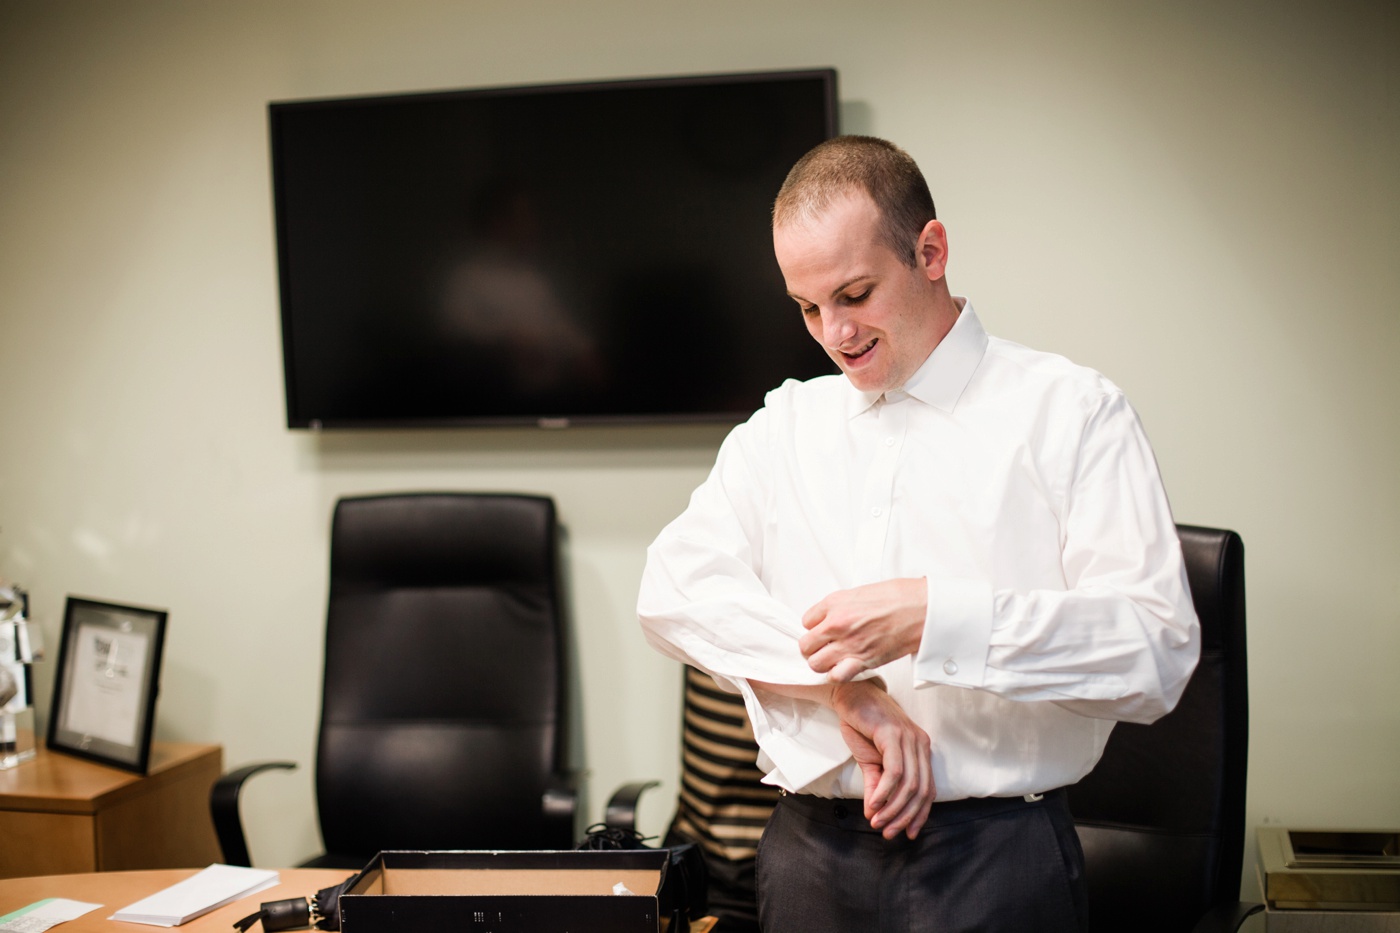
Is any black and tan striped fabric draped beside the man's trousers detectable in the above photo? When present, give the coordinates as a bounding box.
[672,667,778,860]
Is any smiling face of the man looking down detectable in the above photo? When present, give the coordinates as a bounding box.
[773,192,946,391]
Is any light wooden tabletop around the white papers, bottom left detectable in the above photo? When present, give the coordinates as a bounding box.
[0,869,354,933]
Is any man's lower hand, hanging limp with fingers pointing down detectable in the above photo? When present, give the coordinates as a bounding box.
[832,681,937,839]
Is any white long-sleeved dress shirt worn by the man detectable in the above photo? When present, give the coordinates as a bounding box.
[637,298,1200,800]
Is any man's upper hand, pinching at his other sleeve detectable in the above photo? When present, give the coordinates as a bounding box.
[798,577,928,684]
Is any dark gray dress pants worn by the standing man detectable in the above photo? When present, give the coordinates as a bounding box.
[757,790,1088,933]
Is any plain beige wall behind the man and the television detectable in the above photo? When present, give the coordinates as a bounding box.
[0,0,1400,896]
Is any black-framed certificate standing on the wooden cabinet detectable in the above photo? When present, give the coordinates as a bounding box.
[48,595,169,775]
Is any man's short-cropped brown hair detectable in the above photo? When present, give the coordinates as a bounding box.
[773,136,937,266]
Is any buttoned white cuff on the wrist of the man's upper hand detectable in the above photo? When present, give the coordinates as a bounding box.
[914,580,993,686]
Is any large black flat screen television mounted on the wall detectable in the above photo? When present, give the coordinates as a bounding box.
[269,70,836,429]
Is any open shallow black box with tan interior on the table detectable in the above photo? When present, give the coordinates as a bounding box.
[340,849,672,933]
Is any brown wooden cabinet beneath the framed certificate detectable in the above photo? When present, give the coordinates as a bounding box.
[0,742,224,874]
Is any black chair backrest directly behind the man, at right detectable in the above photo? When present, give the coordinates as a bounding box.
[1070,525,1249,933]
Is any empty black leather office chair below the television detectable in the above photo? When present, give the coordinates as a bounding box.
[210,493,577,869]
